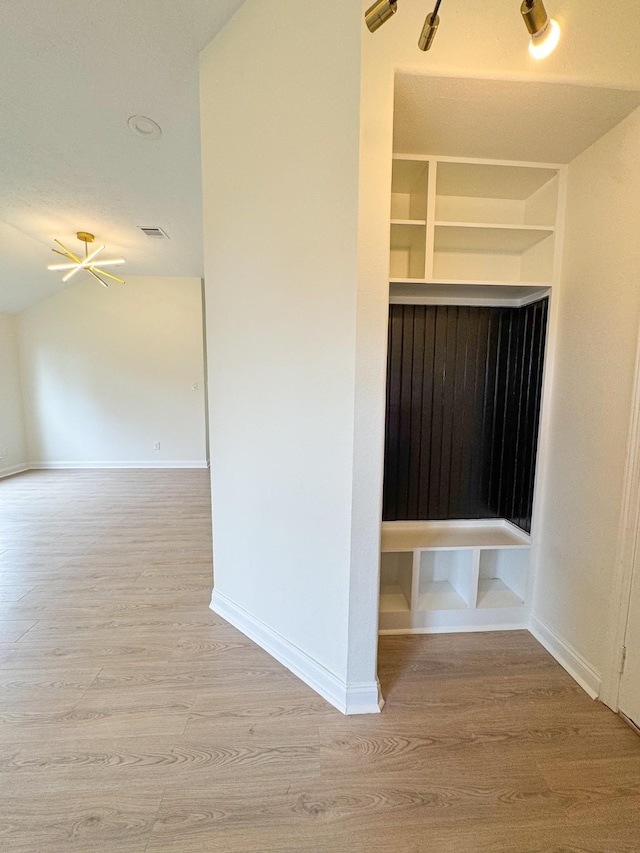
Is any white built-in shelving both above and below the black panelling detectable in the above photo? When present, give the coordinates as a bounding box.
[379,154,563,633]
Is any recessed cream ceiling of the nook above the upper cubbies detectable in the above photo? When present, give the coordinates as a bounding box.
[394,74,640,163]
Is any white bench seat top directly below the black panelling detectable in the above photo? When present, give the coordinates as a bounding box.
[382,519,531,553]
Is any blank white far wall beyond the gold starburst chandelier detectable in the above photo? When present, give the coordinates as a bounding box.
[18,276,206,467]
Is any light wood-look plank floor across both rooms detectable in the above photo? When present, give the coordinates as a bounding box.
[0,471,640,853]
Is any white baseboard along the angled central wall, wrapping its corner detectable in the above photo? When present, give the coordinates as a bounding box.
[211,589,383,714]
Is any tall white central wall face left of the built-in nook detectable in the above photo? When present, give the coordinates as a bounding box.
[201,0,362,682]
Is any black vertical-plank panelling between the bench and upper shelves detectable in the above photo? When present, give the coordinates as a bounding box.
[383,299,547,531]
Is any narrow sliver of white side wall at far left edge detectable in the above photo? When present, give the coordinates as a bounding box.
[0,314,26,476]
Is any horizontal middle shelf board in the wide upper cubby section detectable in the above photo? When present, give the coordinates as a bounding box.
[434,222,553,254]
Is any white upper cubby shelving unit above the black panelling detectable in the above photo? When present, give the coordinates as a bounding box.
[390,154,560,286]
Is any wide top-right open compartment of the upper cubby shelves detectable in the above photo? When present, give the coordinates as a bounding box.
[435,161,558,229]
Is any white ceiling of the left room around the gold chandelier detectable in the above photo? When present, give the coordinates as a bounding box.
[0,0,243,313]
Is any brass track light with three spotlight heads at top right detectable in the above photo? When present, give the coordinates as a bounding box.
[364,0,560,59]
